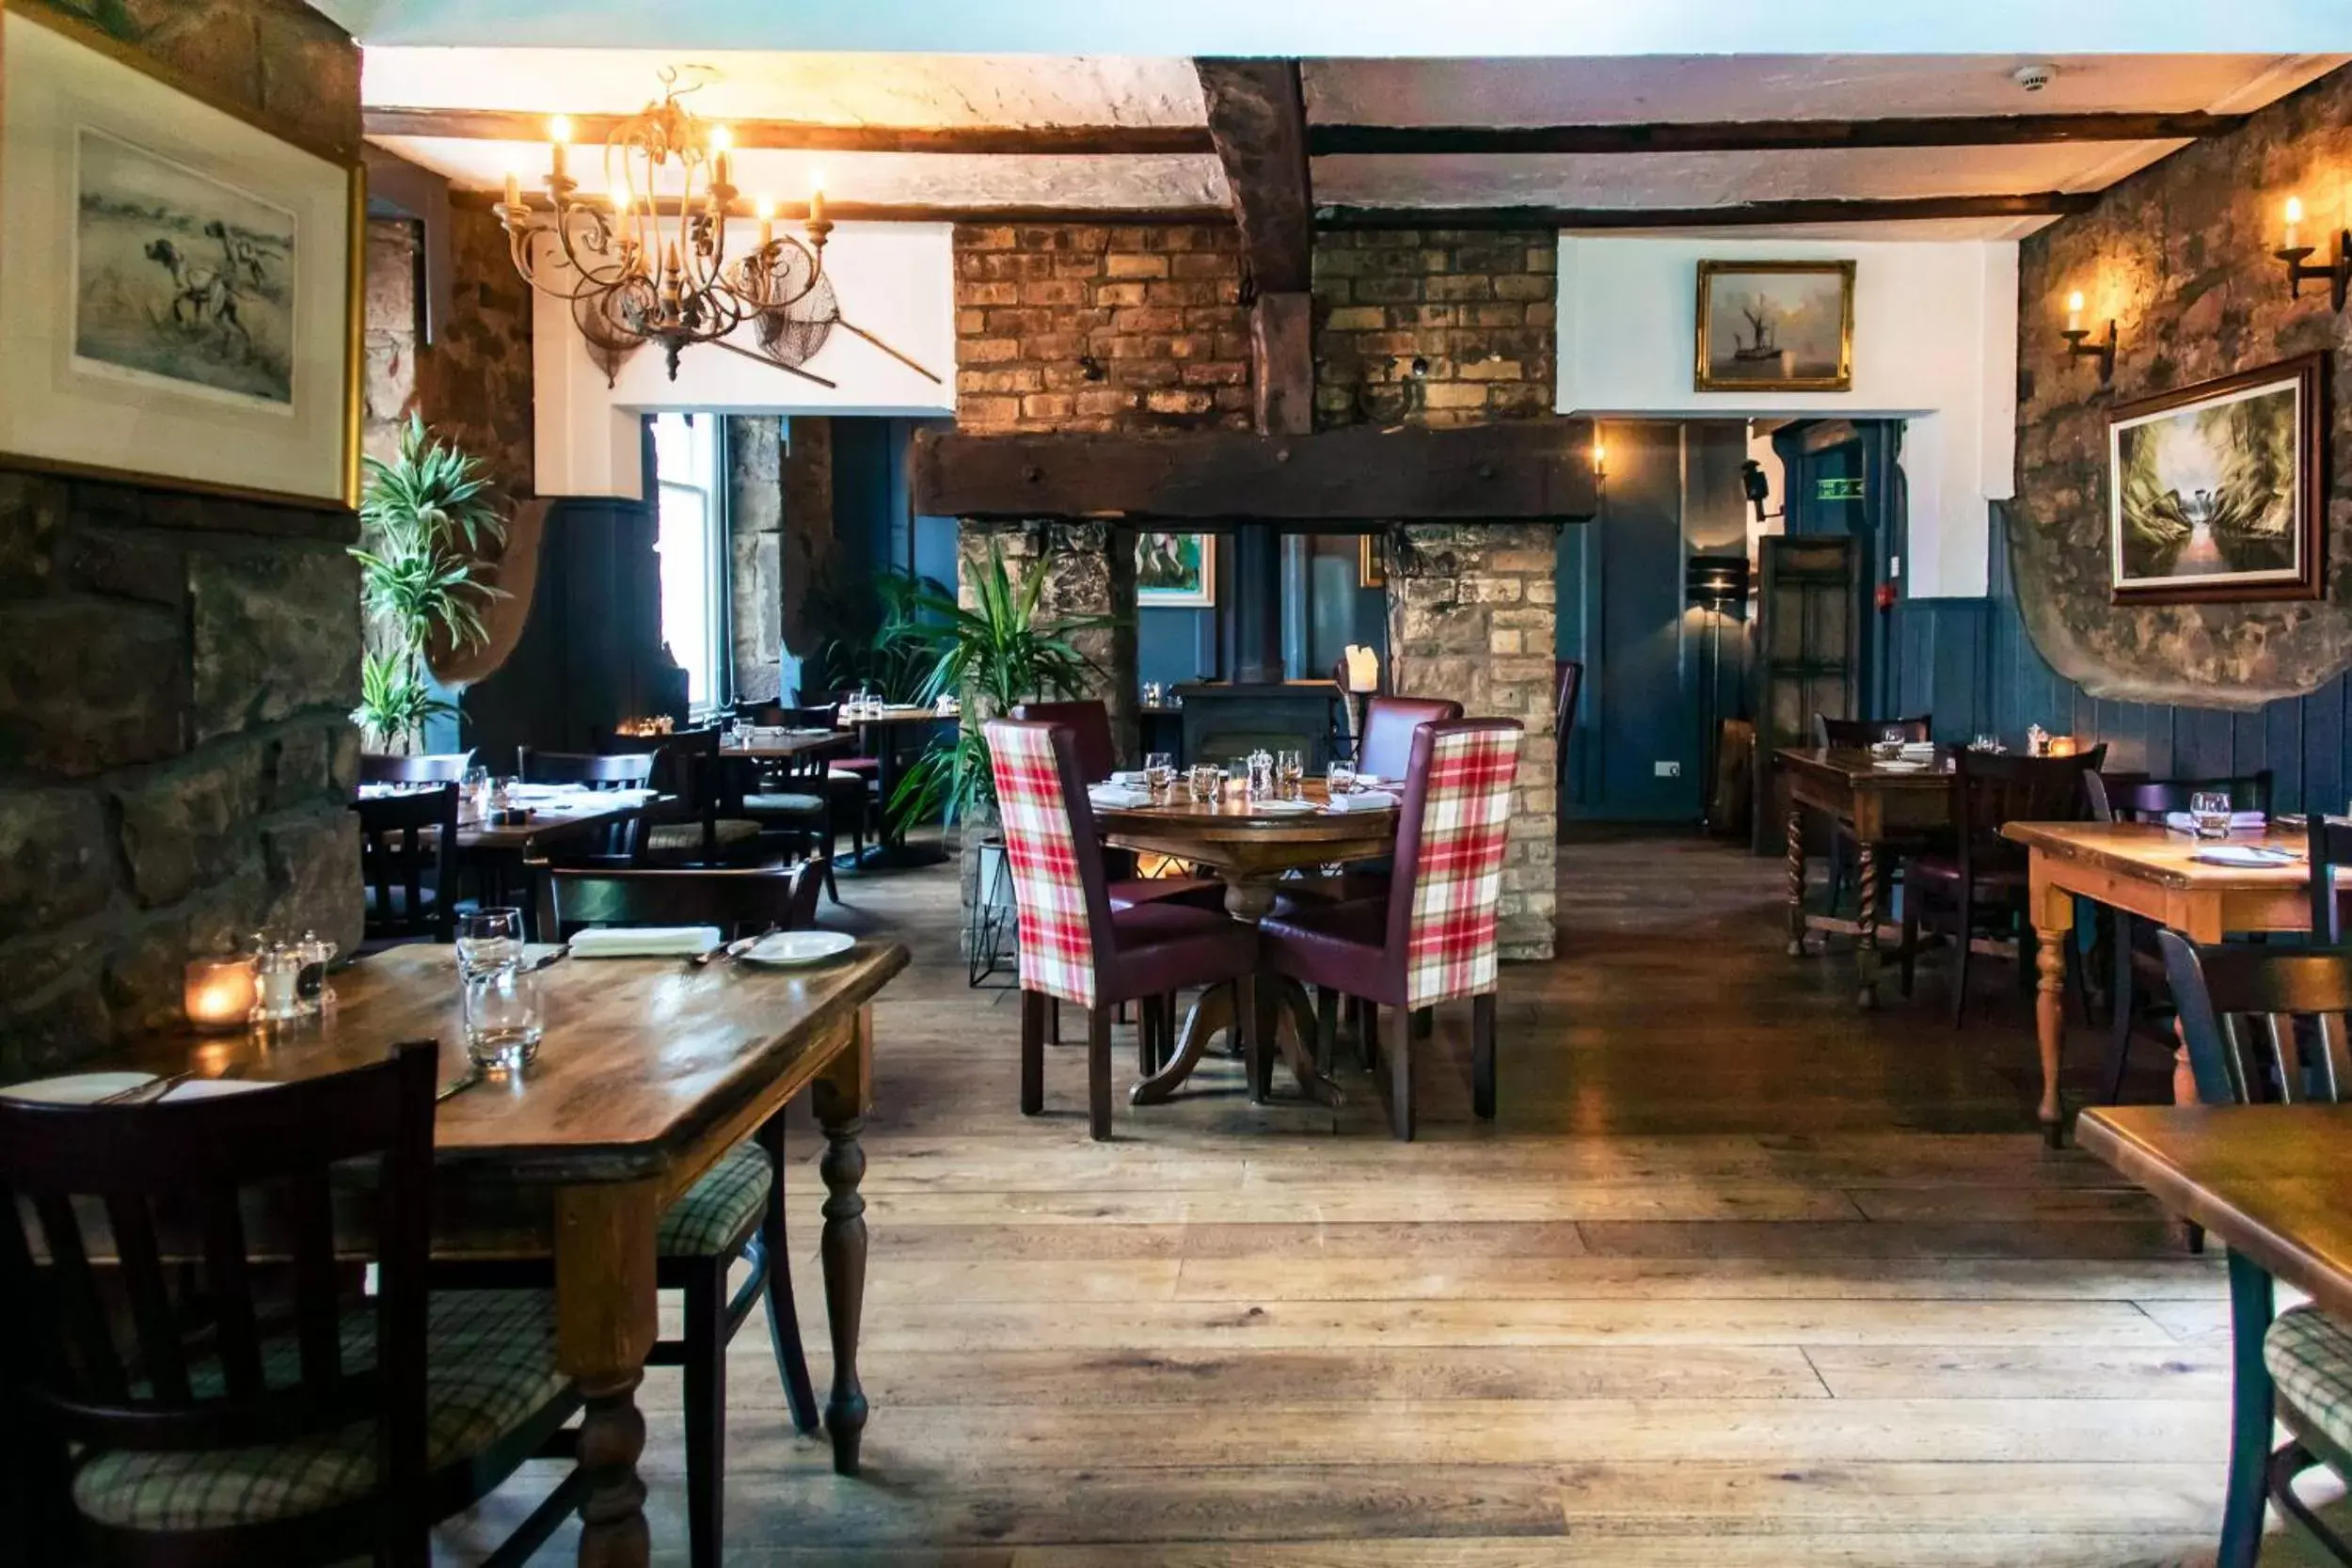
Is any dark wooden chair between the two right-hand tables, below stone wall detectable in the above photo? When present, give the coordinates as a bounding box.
[1903,745,2107,1030]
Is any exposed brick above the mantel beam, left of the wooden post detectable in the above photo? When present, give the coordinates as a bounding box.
[955,223,1249,430]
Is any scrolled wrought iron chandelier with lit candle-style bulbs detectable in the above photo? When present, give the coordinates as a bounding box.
[499,71,833,381]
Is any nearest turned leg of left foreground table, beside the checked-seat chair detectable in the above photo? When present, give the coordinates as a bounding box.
[555,1182,661,1568]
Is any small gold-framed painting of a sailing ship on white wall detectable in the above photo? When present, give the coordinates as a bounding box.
[1693,261,1853,392]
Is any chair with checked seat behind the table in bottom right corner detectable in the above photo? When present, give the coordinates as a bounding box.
[2157,931,2352,1563]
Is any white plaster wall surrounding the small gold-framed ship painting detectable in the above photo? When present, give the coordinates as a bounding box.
[1557,235,2018,597]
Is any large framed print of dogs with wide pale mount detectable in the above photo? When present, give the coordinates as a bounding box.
[0,9,365,505]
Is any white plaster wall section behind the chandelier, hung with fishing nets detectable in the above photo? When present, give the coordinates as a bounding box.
[532,223,955,500]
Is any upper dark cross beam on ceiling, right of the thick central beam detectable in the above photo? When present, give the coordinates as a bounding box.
[1308,113,2247,157]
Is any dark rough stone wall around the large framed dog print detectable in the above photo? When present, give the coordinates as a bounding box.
[0,0,360,1079]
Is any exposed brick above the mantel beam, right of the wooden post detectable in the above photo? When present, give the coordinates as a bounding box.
[1315,228,1560,425]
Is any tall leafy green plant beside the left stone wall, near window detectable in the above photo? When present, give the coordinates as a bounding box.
[351,414,506,750]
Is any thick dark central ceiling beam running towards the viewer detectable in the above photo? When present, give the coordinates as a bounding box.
[1193,58,1315,293]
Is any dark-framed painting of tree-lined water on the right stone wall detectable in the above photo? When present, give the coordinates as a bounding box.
[2107,355,2328,604]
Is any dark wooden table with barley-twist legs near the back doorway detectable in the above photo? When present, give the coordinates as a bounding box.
[1773,745,1952,1008]
